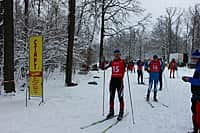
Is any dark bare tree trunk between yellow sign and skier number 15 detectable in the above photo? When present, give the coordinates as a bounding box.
[65,0,76,86]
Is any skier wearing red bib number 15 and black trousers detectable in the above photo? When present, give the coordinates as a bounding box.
[104,49,126,120]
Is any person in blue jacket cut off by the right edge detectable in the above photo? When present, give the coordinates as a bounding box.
[182,53,200,133]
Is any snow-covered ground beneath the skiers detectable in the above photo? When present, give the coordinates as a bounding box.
[0,68,196,133]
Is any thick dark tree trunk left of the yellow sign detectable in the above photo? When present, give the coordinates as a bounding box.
[4,0,15,93]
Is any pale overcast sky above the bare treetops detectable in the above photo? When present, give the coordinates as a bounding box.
[138,0,200,18]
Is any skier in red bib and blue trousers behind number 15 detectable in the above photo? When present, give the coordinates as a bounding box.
[146,55,161,102]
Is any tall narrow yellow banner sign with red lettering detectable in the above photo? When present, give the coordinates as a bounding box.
[29,36,43,97]
